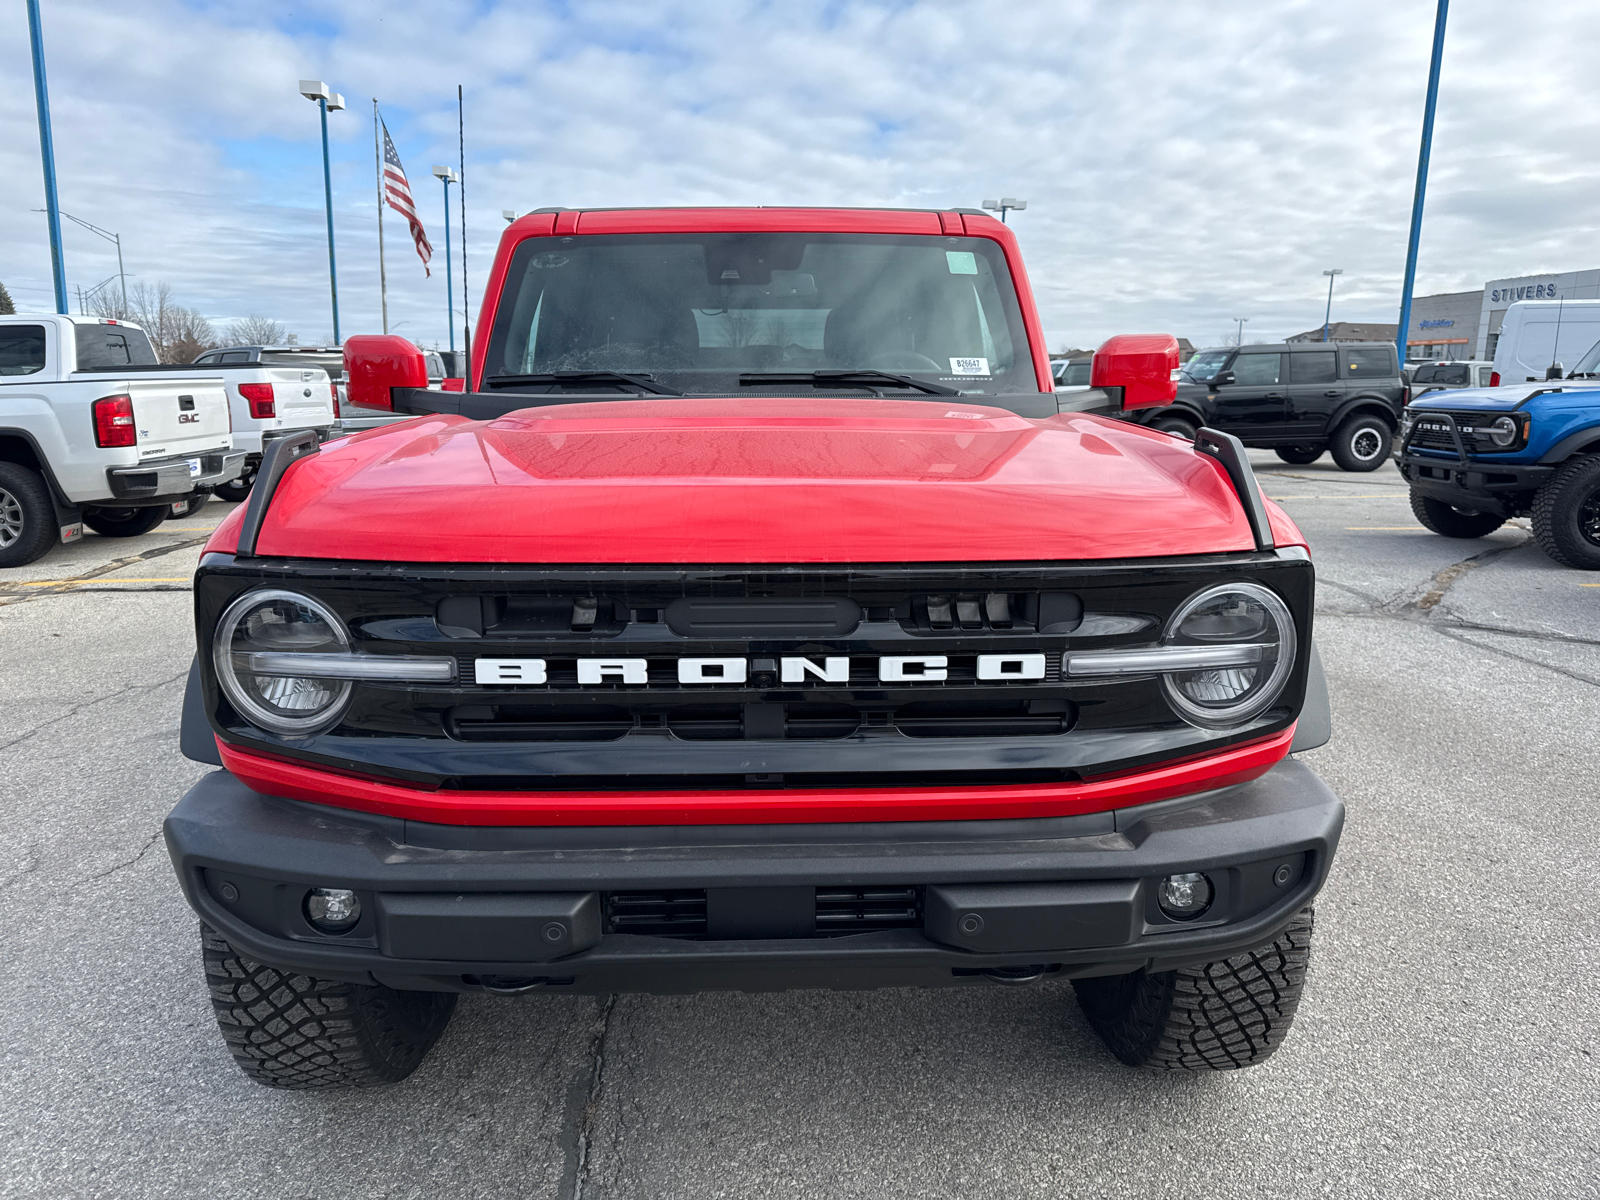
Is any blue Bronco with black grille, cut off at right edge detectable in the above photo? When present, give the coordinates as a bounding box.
[1398,334,1600,571]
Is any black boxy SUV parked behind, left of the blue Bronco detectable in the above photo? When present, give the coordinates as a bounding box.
[1126,342,1406,470]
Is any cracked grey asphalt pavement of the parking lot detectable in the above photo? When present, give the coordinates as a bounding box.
[0,453,1600,1200]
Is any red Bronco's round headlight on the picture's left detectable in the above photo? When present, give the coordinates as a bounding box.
[211,589,350,734]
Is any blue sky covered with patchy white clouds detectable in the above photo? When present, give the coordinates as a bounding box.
[0,0,1600,349]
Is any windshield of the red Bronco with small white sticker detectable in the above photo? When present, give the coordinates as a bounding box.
[485,234,1038,395]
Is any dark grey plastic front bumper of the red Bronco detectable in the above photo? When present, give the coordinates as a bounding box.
[165,760,1344,994]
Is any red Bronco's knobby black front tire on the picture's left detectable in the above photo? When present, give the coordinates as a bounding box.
[200,925,456,1091]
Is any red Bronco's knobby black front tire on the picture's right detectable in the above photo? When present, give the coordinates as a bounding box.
[1072,909,1312,1070]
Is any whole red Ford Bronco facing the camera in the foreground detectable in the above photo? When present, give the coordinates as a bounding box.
[166,208,1344,1088]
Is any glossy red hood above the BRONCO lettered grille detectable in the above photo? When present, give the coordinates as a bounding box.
[208,398,1301,563]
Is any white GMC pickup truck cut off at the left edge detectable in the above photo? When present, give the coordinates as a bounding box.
[0,314,245,568]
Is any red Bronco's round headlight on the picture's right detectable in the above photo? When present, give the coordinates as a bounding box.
[1162,584,1294,728]
